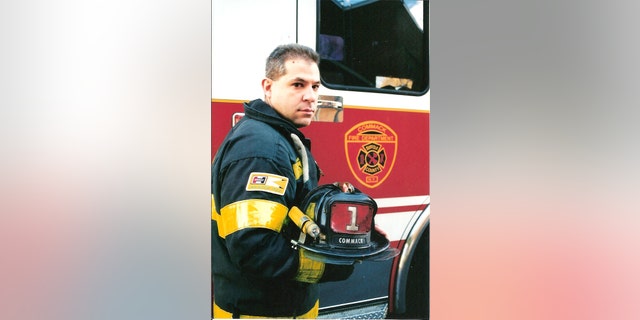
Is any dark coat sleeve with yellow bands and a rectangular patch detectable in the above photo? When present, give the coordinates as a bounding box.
[218,148,332,283]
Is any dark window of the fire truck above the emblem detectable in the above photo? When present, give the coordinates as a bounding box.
[317,0,429,94]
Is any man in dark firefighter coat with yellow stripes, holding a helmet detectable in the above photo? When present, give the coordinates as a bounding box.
[211,44,353,318]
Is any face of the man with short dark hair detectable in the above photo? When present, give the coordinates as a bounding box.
[262,58,320,128]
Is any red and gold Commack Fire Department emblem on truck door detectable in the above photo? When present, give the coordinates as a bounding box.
[344,121,398,188]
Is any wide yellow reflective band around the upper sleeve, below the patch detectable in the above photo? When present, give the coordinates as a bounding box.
[216,199,289,238]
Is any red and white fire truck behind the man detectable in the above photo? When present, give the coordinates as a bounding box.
[211,0,430,319]
